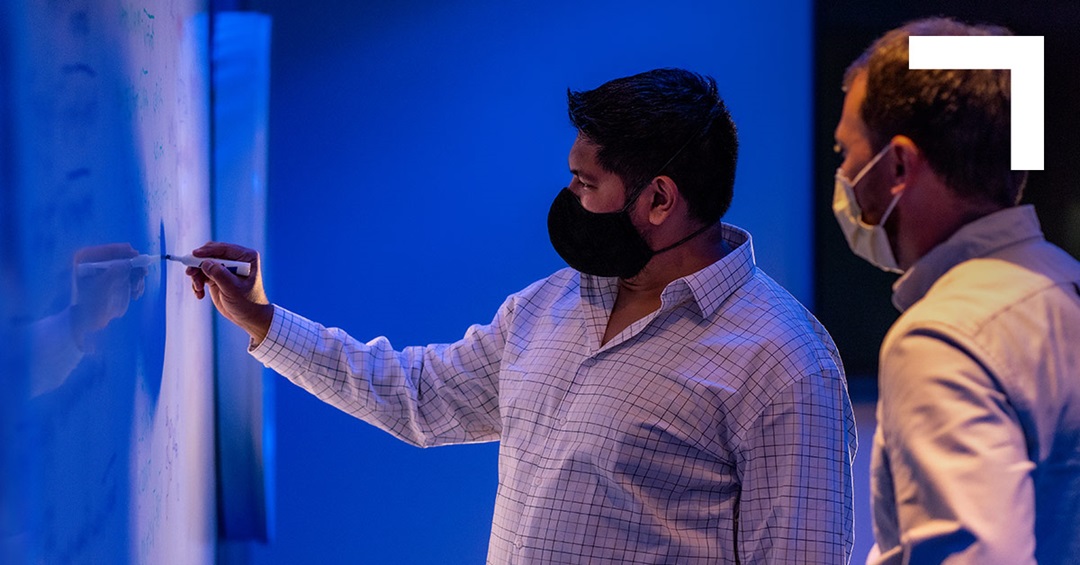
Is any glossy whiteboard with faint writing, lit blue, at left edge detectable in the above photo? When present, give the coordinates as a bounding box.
[0,0,216,564]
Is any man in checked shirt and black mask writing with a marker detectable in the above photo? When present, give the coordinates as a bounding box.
[188,69,855,564]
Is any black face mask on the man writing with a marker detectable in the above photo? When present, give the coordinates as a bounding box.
[548,188,710,279]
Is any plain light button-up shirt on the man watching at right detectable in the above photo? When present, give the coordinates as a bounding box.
[868,206,1080,565]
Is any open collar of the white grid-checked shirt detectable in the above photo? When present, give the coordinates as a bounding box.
[581,224,755,318]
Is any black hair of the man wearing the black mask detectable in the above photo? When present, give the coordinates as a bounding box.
[567,69,739,224]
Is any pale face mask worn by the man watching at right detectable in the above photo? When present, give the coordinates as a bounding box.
[833,145,904,273]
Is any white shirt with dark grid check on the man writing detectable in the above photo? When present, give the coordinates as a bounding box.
[253,225,855,564]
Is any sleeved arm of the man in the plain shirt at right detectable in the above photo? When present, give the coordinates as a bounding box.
[878,332,1035,563]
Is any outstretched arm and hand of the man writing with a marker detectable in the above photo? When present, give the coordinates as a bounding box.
[187,243,512,446]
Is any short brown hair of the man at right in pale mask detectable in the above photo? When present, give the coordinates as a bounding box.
[843,17,1027,206]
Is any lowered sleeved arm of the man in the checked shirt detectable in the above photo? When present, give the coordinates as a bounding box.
[738,375,855,563]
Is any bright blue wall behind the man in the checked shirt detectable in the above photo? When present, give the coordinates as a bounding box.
[243,0,815,564]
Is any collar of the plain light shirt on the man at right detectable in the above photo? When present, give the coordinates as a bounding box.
[892,204,1042,312]
